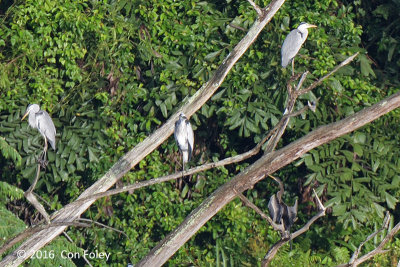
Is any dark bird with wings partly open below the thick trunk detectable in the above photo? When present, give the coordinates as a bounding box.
[268,176,297,247]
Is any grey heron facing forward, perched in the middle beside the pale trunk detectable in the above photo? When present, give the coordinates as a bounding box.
[174,113,194,171]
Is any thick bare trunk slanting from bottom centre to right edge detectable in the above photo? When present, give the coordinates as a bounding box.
[136,92,400,266]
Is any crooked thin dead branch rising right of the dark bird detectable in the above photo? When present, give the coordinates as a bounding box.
[261,190,326,267]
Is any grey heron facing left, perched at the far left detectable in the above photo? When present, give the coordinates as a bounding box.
[22,104,56,165]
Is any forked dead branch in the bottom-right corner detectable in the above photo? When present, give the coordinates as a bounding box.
[337,213,400,267]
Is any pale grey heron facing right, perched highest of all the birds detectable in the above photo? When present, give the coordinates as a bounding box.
[281,22,317,75]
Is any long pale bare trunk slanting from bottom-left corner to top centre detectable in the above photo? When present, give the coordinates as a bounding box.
[0,0,285,266]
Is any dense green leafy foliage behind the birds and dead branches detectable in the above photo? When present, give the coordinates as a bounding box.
[0,0,400,266]
